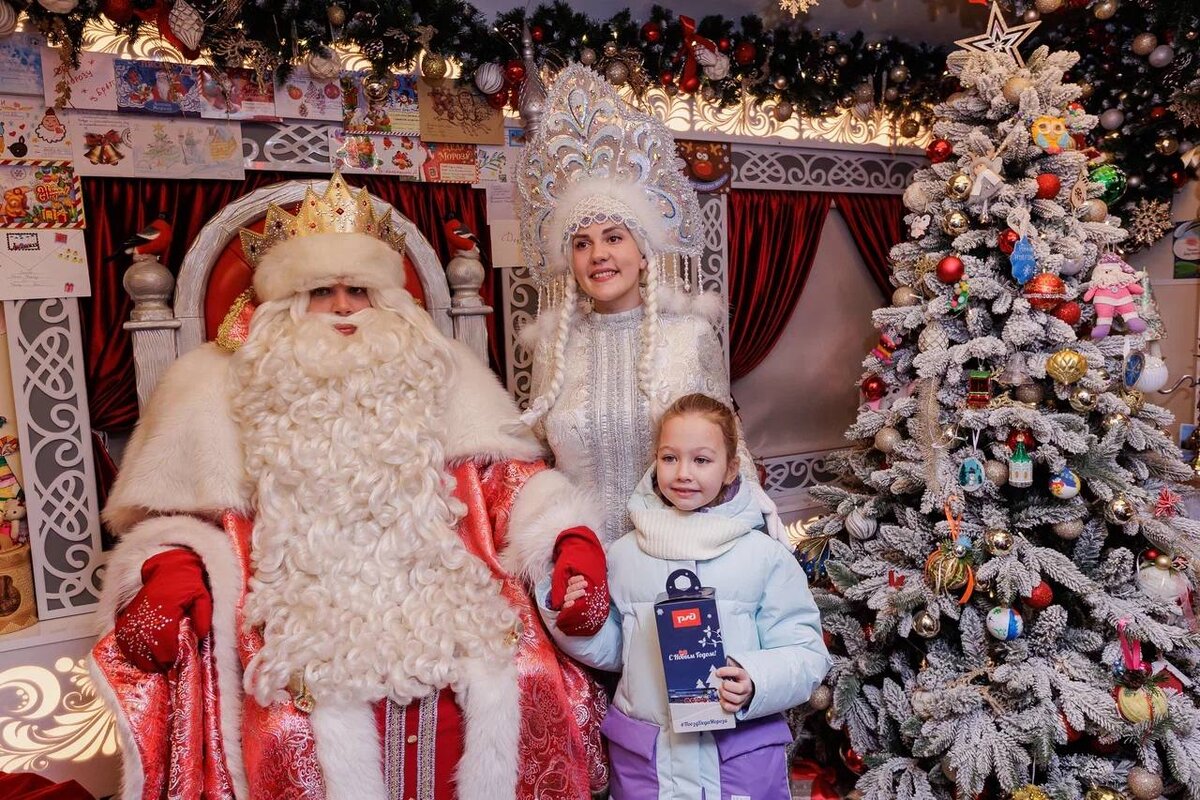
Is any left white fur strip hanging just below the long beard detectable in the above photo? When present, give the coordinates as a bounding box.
[308,703,388,800]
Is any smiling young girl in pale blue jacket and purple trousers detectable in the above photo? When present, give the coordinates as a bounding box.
[536,395,829,800]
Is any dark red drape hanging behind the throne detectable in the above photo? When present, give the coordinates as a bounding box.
[79,172,492,431]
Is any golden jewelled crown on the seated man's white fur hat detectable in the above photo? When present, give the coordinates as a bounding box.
[241,173,404,267]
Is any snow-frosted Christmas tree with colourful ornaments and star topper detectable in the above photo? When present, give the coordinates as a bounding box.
[798,10,1200,800]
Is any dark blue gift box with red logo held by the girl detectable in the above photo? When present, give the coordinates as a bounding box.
[654,570,736,733]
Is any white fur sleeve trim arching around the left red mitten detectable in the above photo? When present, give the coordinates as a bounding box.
[97,516,250,798]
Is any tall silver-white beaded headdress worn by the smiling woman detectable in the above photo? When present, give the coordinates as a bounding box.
[517,65,702,303]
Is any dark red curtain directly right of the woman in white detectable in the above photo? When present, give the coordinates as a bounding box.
[728,190,832,380]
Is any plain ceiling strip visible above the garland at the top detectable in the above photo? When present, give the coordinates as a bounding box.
[472,0,988,44]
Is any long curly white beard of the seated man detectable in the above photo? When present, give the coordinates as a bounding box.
[234,302,517,705]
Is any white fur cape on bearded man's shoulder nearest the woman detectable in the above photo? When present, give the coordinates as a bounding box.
[444,341,546,462]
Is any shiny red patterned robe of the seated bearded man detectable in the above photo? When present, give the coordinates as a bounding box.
[94,461,607,800]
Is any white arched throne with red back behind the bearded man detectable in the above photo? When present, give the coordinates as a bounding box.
[124,180,492,407]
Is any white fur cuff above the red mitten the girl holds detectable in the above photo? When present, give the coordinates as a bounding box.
[500,469,604,587]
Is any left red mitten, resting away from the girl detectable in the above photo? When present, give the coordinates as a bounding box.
[115,548,212,673]
